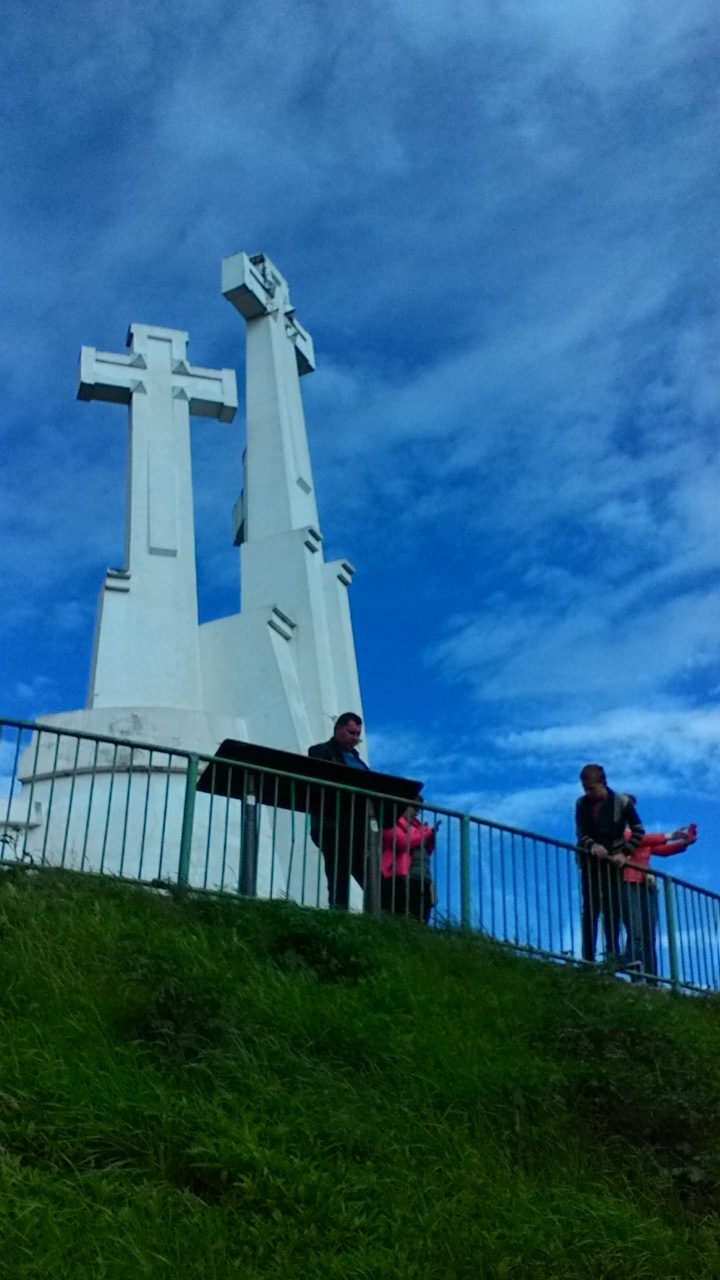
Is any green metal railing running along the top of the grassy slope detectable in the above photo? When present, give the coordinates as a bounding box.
[0,719,720,991]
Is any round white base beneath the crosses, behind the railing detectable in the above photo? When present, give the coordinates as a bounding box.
[13,707,327,906]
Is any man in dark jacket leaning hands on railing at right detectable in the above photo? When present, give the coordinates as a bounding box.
[575,764,644,960]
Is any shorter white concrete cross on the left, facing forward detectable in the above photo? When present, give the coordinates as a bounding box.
[78,324,237,709]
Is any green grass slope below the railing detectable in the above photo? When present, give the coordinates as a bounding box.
[0,870,720,1280]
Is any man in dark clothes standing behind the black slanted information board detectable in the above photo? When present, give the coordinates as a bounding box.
[307,712,368,910]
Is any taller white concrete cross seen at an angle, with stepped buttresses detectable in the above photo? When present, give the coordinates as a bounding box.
[200,253,361,751]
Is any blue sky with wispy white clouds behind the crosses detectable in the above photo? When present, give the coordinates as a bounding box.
[0,0,720,891]
